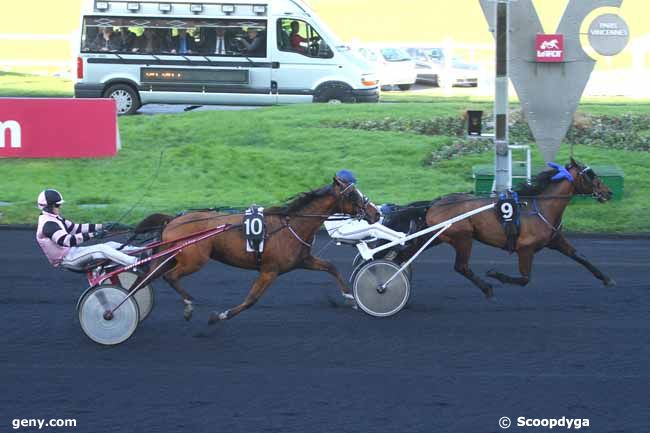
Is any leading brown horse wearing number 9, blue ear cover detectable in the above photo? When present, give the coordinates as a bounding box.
[410,158,615,298]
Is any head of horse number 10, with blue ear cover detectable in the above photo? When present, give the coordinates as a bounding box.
[332,170,381,224]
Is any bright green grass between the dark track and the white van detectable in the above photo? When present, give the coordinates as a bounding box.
[0,73,650,232]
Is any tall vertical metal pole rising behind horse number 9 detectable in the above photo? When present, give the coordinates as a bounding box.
[494,0,511,192]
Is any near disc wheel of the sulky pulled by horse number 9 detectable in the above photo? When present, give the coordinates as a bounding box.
[353,260,411,317]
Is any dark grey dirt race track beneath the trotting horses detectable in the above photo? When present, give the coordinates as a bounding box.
[0,231,650,433]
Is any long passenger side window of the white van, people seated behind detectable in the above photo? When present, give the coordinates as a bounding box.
[81,16,267,57]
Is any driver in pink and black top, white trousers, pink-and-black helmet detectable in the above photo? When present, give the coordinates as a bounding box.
[36,189,138,269]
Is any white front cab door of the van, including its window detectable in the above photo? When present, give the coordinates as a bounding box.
[272,18,339,103]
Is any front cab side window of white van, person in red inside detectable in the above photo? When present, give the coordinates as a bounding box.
[277,18,334,59]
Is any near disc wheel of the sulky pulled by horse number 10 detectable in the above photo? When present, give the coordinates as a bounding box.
[78,285,140,346]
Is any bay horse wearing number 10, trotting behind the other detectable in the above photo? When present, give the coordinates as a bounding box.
[141,170,380,324]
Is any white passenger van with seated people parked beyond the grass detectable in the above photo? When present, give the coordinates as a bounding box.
[75,0,380,114]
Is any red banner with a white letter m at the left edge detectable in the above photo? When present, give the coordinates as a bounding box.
[0,98,119,158]
